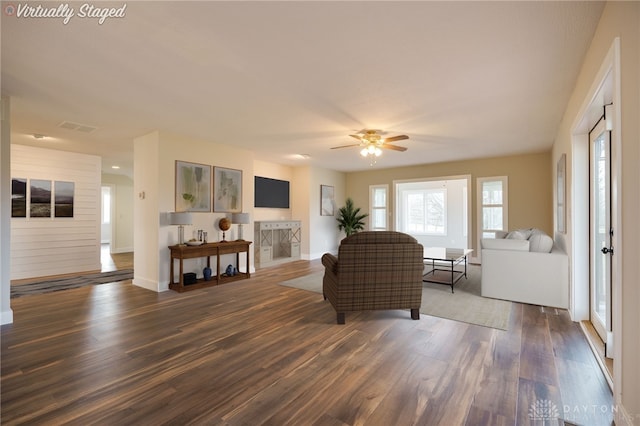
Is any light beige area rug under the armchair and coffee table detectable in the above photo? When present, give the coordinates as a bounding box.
[280,265,511,330]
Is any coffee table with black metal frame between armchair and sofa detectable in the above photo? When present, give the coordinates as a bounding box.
[422,247,473,293]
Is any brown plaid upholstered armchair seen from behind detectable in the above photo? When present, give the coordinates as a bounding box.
[322,231,424,324]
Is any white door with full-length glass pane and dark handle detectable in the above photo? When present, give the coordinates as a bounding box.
[589,120,614,342]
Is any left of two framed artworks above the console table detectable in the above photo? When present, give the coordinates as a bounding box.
[176,160,211,212]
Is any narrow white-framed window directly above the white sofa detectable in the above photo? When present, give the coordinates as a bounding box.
[478,176,508,238]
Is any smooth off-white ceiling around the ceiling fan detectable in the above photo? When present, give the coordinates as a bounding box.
[1,1,603,175]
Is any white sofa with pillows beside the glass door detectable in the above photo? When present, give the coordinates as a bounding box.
[481,229,569,309]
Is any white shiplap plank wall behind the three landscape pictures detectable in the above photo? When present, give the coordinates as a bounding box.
[11,145,101,280]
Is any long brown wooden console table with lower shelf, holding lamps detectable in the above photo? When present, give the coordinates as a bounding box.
[169,241,251,292]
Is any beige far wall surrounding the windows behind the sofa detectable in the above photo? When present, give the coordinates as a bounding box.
[347,152,553,255]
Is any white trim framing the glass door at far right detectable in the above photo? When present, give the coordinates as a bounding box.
[569,38,623,401]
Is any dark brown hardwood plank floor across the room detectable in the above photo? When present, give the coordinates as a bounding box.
[0,255,613,426]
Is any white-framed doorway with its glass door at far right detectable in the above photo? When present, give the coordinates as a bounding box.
[559,38,624,392]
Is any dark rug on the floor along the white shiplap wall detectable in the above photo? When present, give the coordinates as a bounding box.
[11,269,133,298]
